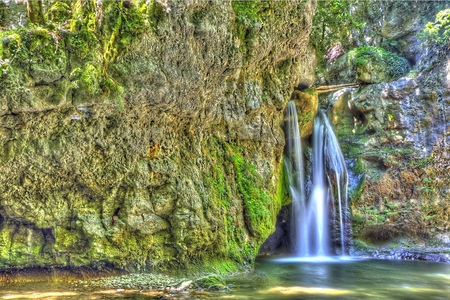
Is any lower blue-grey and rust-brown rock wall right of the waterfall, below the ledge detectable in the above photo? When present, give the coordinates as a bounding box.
[332,59,450,246]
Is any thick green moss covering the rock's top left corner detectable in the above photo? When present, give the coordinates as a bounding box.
[0,0,151,109]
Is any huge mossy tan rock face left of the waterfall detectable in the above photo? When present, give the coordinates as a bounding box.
[0,1,314,269]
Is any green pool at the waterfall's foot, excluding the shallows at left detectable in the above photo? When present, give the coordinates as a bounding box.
[223,258,450,300]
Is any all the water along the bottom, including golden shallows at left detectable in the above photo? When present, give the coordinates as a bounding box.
[0,258,450,300]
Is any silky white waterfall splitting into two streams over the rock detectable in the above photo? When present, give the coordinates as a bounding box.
[284,101,348,257]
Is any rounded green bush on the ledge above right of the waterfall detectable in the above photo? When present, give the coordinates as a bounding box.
[349,46,409,78]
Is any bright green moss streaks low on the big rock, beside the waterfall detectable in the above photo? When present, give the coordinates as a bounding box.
[197,138,281,266]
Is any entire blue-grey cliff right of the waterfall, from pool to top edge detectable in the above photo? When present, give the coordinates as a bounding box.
[316,1,450,252]
